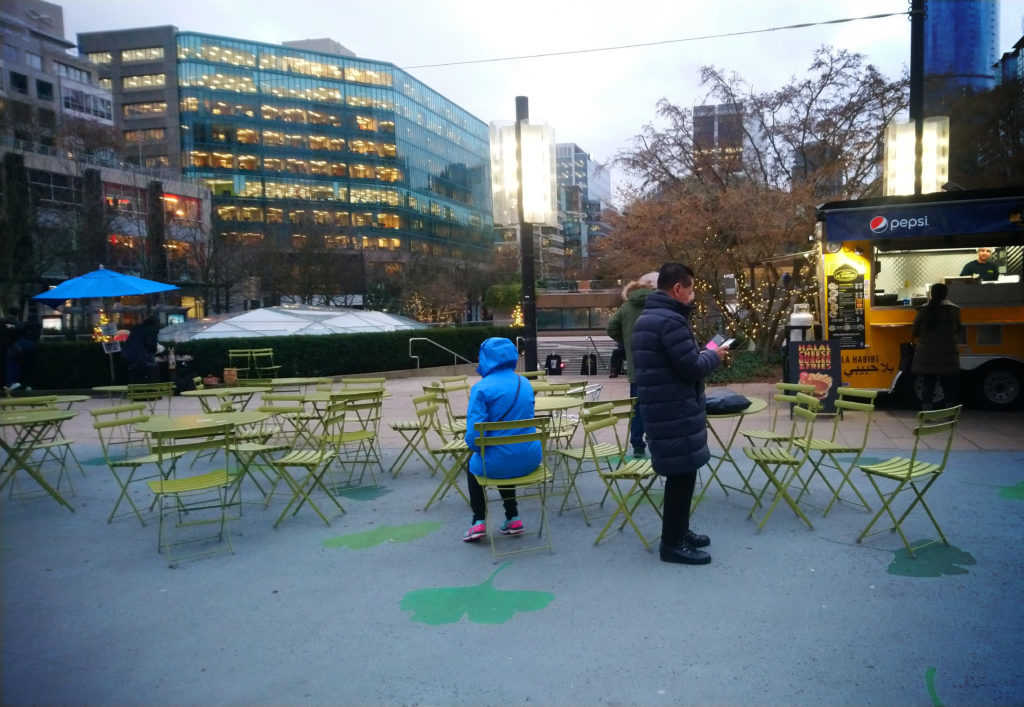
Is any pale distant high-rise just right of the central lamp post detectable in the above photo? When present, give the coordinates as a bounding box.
[555,142,611,268]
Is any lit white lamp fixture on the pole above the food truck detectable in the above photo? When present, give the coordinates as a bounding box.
[883,116,949,197]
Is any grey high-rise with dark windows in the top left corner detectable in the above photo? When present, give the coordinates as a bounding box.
[0,0,114,154]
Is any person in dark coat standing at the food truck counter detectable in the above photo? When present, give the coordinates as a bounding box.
[910,283,962,410]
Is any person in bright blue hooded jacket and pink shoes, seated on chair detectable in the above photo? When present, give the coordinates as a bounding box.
[463,337,542,542]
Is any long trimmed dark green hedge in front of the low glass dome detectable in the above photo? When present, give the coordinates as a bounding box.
[29,327,518,389]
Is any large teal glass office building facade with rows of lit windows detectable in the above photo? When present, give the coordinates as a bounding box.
[176,32,494,259]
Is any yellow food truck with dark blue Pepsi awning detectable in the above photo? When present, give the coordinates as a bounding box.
[815,188,1024,409]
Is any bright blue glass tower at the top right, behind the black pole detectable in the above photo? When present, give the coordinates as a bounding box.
[925,0,999,116]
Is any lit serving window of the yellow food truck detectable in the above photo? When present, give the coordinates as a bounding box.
[871,241,1024,306]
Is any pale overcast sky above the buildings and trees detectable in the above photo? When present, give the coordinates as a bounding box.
[56,0,1024,198]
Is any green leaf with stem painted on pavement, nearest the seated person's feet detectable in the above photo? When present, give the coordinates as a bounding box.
[400,563,555,626]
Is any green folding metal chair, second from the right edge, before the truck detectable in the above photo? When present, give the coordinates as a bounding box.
[794,386,878,516]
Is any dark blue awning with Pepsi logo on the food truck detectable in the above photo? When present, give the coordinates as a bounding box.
[817,186,1024,250]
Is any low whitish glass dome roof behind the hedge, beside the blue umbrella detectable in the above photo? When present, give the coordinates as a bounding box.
[160,306,427,341]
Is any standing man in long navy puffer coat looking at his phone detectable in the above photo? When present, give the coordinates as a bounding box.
[633,262,727,565]
